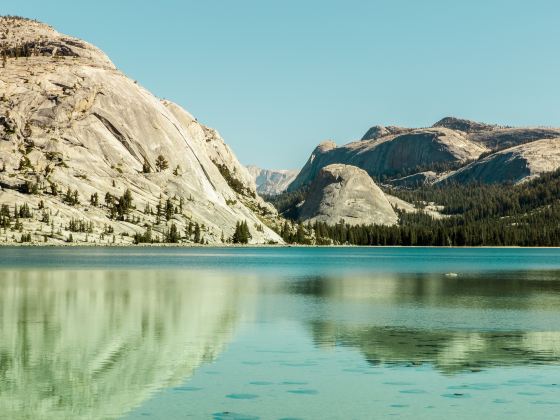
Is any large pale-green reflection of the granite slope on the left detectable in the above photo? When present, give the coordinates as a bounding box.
[0,270,255,419]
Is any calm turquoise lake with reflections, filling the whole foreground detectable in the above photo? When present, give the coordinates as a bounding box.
[0,248,560,419]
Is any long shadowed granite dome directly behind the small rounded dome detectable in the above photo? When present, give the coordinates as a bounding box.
[288,128,487,191]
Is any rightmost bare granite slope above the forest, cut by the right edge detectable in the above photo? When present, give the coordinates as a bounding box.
[438,137,560,184]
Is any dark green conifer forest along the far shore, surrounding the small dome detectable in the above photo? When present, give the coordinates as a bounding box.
[270,171,560,246]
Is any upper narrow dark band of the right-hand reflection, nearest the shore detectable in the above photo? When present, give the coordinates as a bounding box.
[288,271,560,310]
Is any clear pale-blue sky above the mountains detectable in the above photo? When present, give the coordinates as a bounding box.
[0,0,560,168]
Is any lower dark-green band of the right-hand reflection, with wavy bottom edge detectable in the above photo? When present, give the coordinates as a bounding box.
[311,322,560,373]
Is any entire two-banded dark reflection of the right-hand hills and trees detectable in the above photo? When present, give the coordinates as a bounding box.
[300,272,560,373]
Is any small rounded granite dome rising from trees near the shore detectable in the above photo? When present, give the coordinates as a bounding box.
[299,164,398,225]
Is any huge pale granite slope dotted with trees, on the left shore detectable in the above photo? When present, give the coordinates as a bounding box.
[0,17,281,244]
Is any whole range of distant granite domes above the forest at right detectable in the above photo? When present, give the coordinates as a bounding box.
[288,117,560,191]
